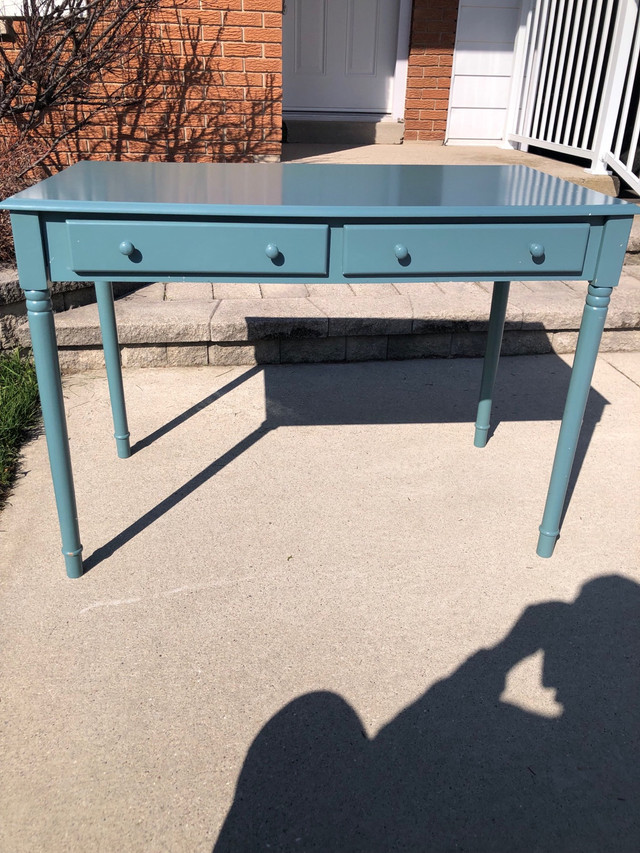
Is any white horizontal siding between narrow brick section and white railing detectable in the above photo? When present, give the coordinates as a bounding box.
[447,0,521,144]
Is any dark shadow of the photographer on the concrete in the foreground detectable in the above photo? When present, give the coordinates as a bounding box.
[214,576,640,853]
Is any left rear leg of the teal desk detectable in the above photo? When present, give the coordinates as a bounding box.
[95,281,131,459]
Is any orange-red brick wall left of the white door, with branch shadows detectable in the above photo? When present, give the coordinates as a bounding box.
[1,0,282,167]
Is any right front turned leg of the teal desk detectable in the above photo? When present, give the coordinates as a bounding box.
[537,284,612,557]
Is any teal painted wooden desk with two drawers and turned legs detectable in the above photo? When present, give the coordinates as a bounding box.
[1,162,635,577]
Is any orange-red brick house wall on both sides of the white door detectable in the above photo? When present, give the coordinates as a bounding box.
[2,0,458,166]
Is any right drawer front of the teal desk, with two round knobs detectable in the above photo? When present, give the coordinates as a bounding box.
[343,223,589,277]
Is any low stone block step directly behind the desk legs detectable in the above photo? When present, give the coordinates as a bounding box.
[16,264,640,371]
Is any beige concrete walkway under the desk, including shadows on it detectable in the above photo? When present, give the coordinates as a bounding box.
[0,353,640,853]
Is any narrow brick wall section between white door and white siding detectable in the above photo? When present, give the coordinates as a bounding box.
[404,0,458,142]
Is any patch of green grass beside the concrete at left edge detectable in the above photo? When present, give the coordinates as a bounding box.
[0,350,40,508]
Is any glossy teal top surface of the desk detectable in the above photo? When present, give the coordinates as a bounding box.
[0,161,636,219]
